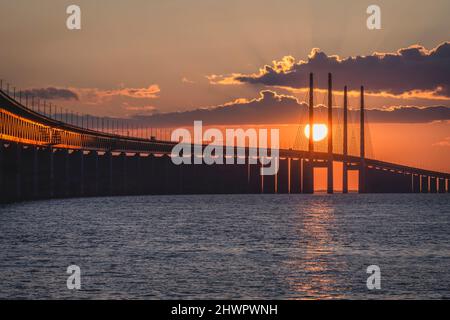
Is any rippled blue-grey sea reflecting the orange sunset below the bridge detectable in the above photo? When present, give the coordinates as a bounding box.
[0,194,450,299]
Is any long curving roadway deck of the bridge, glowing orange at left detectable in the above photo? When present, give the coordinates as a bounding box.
[0,91,450,179]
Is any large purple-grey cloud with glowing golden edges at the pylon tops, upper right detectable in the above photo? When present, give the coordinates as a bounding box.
[207,42,450,100]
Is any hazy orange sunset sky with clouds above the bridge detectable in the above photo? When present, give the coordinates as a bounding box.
[0,0,450,171]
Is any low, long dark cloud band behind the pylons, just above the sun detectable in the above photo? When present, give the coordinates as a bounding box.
[135,90,450,127]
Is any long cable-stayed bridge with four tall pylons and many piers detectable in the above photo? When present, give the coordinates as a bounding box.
[0,74,450,203]
